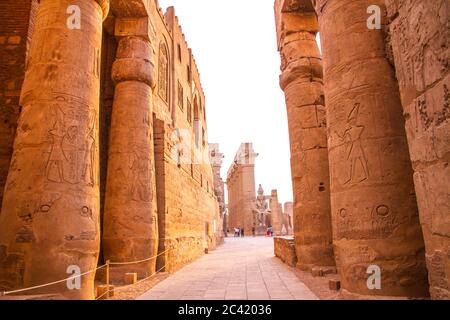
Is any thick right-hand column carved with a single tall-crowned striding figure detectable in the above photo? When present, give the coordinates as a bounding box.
[316,0,428,297]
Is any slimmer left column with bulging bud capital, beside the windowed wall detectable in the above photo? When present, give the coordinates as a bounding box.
[103,36,158,279]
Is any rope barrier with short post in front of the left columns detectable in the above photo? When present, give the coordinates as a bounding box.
[0,249,173,300]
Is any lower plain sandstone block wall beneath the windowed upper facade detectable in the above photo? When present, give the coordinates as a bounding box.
[155,121,219,272]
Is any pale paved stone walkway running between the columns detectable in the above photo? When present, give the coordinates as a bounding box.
[138,237,318,300]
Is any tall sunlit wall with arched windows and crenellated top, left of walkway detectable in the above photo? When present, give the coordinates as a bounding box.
[152,1,222,272]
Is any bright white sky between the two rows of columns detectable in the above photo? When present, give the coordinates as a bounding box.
[159,0,292,202]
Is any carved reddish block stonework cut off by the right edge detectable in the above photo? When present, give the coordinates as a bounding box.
[386,0,450,299]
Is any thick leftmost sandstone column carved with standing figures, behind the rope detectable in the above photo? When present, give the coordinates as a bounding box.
[0,0,109,299]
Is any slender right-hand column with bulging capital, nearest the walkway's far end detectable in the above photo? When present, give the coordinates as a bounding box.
[272,1,335,270]
